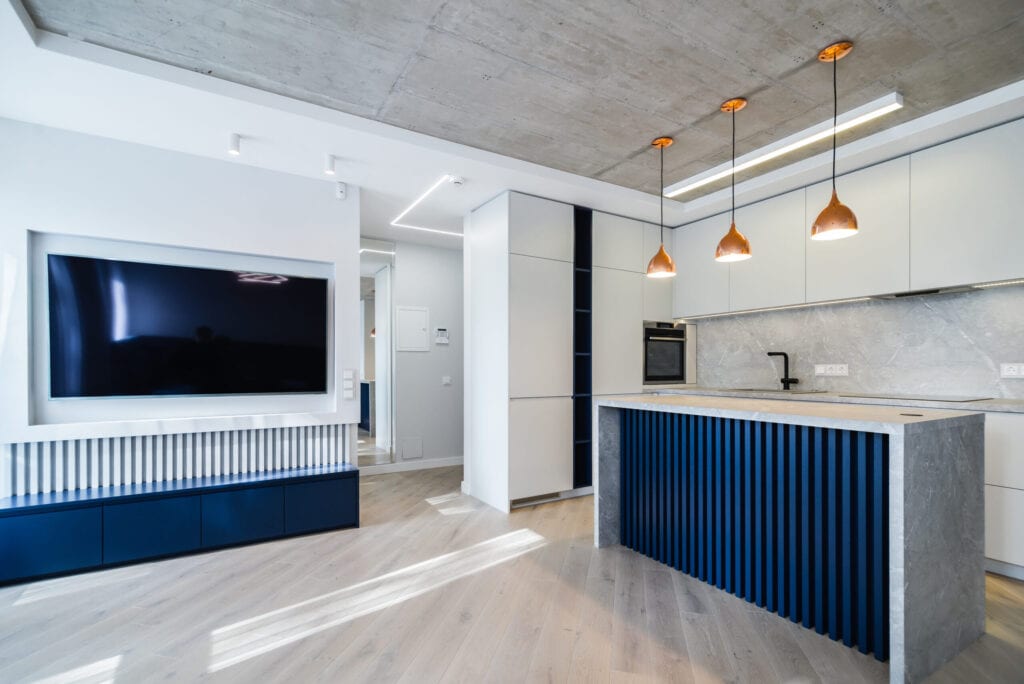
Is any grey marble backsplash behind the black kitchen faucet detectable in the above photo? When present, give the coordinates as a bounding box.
[694,286,1024,398]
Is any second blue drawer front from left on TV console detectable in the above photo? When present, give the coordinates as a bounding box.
[103,496,200,563]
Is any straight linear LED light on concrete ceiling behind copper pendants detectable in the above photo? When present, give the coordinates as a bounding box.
[664,92,903,198]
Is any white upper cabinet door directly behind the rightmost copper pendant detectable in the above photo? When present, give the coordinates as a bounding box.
[804,157,910,302]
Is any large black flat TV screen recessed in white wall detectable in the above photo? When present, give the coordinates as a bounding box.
[47,254,328,398]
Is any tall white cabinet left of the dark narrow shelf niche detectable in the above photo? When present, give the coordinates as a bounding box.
[463,193,573,511]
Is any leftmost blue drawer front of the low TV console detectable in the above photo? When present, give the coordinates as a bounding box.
[0,506,102,582]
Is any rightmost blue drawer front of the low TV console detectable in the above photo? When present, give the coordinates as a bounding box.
[285,477,359,535]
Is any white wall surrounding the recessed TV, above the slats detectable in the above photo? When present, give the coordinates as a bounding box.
[0,120,359,442]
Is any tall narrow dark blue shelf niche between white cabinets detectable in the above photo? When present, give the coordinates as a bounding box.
[572,207,594,487]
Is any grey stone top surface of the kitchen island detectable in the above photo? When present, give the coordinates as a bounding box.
[594,393,982,433]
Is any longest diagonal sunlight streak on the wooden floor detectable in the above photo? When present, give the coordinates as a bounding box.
[208,529,546,673]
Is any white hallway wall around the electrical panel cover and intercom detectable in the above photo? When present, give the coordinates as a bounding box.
[392,243,465,461]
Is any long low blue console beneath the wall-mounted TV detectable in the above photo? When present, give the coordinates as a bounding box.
[0,464,359,584]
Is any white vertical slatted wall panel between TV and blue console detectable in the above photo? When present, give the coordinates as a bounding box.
[0,425,351,498]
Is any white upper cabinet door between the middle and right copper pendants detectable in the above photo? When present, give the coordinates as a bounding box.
[729,189,806,311]
